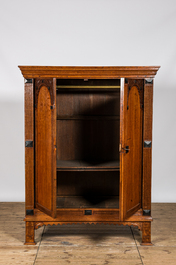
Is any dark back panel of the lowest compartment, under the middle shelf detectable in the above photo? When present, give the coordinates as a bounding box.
[57,171,119,197]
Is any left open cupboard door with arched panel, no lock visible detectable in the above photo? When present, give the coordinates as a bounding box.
[35,78,56,217]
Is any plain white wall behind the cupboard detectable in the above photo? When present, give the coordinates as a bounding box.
[0,0,176,202]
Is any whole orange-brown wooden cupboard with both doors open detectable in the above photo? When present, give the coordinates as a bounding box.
[19,66,159,245]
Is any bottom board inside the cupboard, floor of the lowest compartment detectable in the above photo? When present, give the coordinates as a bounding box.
[57,195,119,209]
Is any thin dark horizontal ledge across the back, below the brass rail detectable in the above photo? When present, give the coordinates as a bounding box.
[57,115,120,120]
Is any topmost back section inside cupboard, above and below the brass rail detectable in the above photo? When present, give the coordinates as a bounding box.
[57,80,120,117]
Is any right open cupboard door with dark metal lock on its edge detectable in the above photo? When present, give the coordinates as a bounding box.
[119,78,144,221]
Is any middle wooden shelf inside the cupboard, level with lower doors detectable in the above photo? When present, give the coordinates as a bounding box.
[57,160,120,171]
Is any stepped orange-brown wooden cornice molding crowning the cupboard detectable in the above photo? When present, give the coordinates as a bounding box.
[18,66,160,79]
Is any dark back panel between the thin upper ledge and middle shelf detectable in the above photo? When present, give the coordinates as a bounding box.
[57,119,120,161]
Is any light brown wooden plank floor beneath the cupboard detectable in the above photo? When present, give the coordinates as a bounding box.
[0,202,176,265]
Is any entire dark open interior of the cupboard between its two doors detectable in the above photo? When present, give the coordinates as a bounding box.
[56,79,120,209]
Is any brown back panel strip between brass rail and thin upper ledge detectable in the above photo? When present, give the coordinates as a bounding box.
[57,91,120,118]
